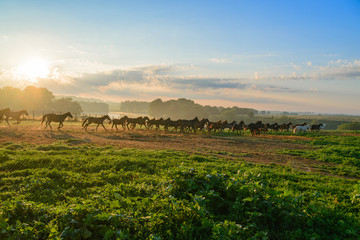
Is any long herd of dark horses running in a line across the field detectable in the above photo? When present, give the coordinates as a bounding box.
[0,108,326,136]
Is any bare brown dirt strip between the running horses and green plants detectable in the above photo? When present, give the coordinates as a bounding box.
[0,124,346,178]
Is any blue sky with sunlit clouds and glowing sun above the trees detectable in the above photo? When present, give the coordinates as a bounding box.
[0,0,360,115]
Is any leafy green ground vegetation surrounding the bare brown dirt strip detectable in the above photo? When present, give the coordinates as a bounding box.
[0,139,360,239]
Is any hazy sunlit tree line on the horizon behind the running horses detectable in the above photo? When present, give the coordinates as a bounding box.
[0,86,258,121]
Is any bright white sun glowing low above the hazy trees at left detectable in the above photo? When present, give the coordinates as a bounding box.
[15,57,50,83]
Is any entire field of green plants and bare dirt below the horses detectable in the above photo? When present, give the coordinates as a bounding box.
[0,122,360,239]
